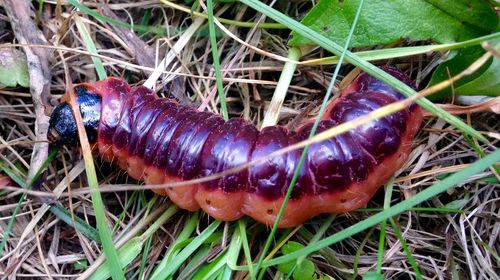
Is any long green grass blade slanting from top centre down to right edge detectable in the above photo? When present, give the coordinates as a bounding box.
[239,0,488,143]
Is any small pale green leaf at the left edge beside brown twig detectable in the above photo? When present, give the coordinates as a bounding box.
[0,48,29,87]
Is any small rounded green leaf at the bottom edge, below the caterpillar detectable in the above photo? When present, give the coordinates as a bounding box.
[278,241,315,280]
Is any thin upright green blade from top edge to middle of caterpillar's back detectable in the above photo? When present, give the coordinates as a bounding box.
[207,0,229,121]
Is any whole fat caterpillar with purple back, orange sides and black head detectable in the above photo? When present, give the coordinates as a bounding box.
[49,67,422,227]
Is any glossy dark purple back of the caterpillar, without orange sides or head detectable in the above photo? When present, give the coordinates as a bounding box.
[95,68,412,200]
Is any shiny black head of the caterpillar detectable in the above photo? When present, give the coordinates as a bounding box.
[47,85,101,146]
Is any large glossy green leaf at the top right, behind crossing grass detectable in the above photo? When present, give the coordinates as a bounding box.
[289,0,498,47]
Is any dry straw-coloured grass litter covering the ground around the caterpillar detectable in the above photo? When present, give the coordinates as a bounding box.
[0,1,500,279]
